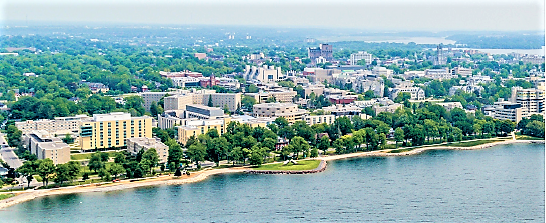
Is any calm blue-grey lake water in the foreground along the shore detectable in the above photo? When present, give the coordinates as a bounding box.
[0,145,545,222]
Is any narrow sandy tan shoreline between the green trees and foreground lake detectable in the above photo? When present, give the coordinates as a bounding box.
[0,140,544,209]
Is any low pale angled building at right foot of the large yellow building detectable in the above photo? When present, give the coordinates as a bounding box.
[127,137,169,163]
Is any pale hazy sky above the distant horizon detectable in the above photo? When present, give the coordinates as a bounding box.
[0,0,545,31]
